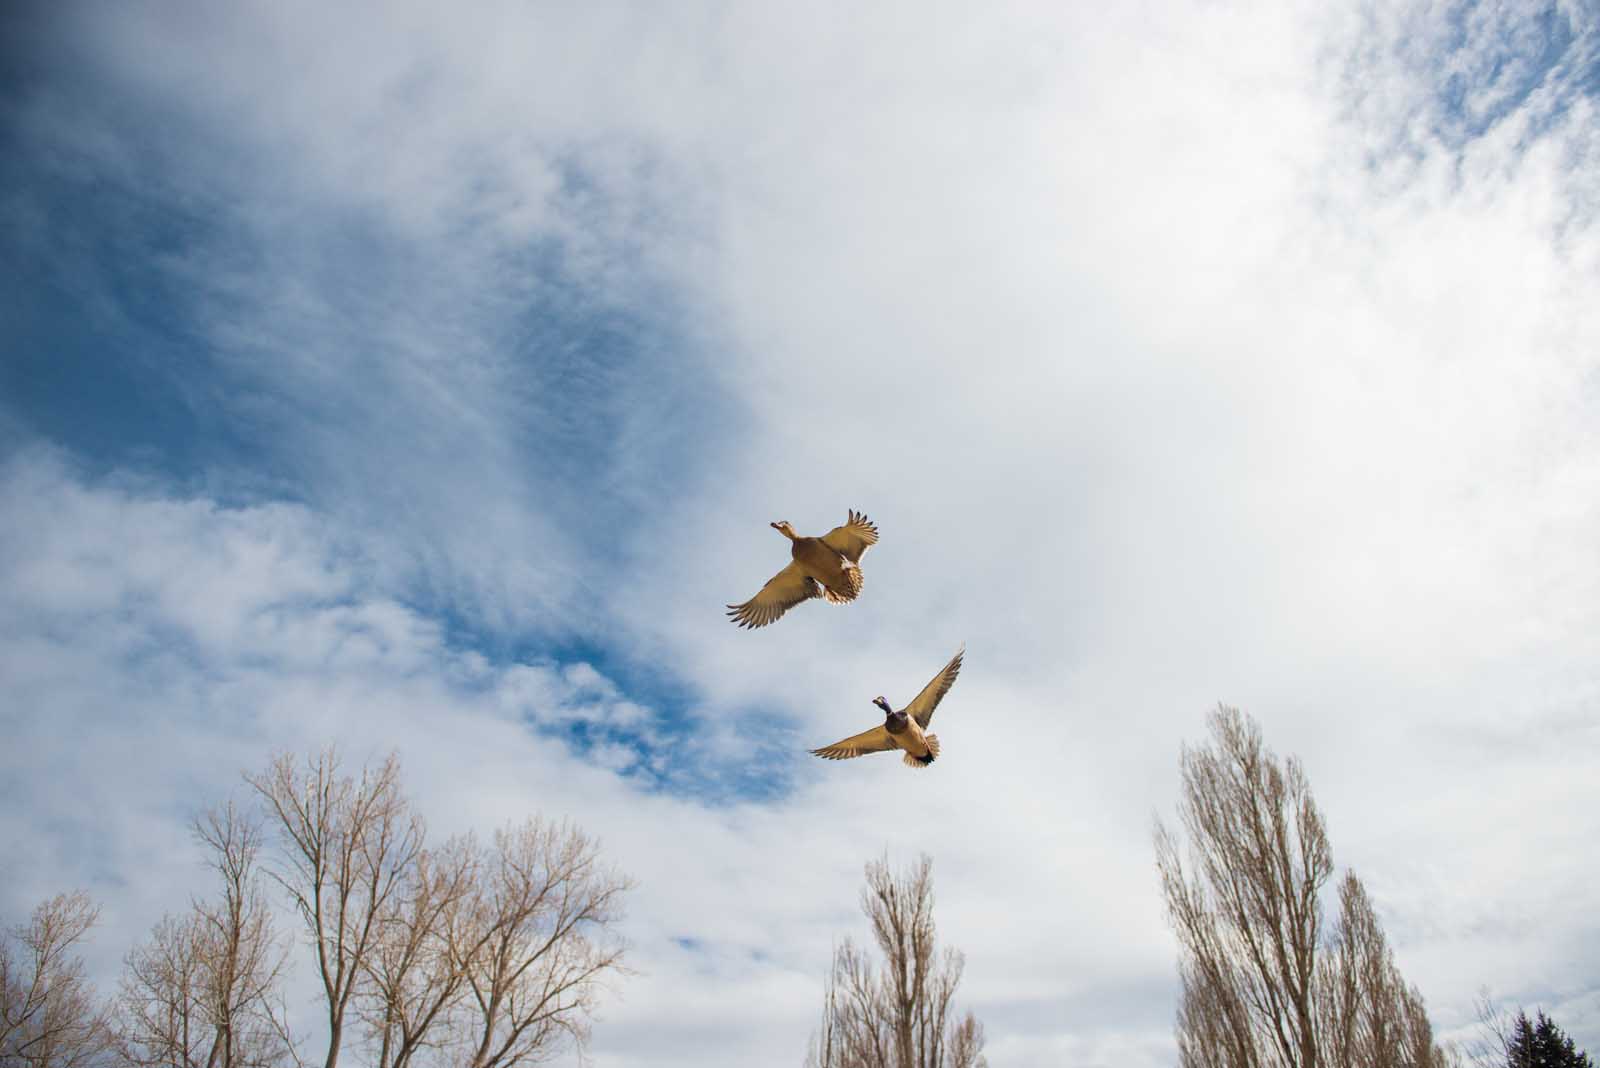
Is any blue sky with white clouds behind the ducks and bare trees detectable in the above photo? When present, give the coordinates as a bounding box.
[0,0,1600,1068]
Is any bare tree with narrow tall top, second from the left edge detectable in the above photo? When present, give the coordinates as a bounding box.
[122,803,293,1068]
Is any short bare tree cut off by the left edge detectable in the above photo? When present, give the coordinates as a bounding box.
[0,892,115,1068]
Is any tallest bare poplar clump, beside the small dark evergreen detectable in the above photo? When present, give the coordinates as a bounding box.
[1155,708,1453,1068]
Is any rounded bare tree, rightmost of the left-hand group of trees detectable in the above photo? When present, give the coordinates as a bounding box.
[453,819,632,1068]
